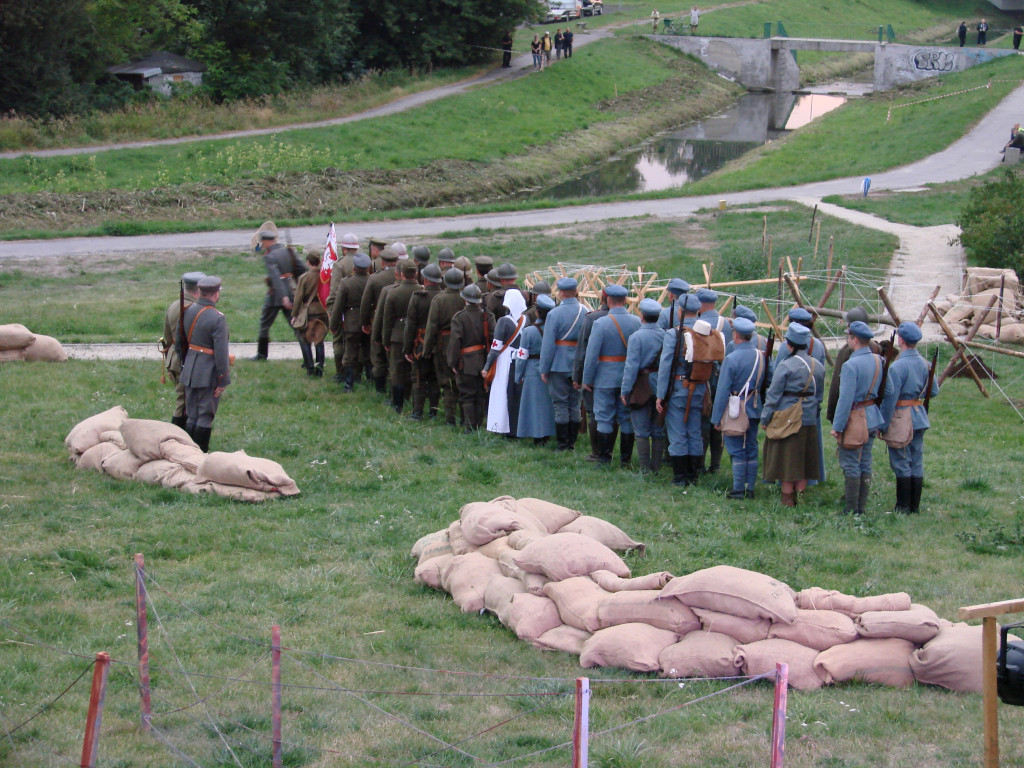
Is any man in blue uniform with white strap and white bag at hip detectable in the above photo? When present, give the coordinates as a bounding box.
[711,317,767,499]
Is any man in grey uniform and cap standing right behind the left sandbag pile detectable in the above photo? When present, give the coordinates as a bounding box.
[175,276,231,452]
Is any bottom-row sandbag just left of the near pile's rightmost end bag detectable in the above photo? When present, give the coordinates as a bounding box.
[814,638,913,688]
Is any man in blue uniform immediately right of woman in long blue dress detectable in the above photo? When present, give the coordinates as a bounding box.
[541,278,587,451]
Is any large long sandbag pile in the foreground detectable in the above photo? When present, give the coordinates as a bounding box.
[412,496,1019,692]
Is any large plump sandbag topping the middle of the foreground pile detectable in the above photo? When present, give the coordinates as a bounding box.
[662,565,797,624]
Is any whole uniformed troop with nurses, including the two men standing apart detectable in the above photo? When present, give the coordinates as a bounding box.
[165,229,938,514]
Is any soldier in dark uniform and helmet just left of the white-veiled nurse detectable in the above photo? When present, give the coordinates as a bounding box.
[447,285,495,432]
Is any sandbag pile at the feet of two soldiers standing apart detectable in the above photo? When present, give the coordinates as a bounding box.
[65,406,299,502]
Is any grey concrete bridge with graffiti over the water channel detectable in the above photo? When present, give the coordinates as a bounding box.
[648,35,1017,93]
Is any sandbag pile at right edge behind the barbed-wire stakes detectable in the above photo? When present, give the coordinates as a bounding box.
[935,266,1024,344]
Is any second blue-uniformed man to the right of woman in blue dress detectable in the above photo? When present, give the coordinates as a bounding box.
[583,283,640,467]
